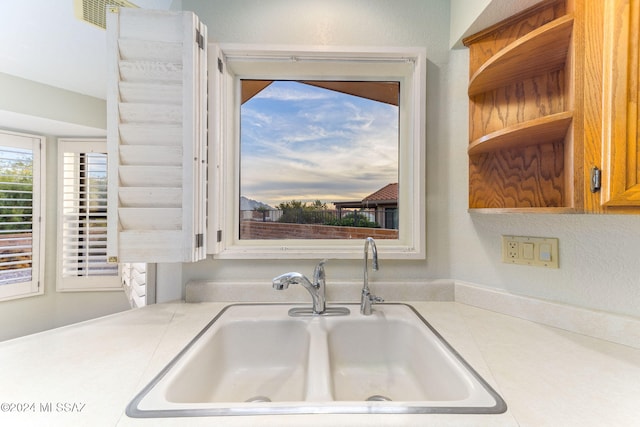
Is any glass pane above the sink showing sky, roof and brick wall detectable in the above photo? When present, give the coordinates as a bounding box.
[239,80,400,240]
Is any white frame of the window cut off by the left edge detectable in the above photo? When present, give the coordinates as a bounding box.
[0,130,46,301]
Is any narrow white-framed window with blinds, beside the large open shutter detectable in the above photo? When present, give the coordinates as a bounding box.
[57,139,122,291]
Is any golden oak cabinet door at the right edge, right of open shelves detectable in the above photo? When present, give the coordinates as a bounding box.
[602,0,640,212]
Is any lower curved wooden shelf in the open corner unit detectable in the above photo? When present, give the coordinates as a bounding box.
[467,111,573,156]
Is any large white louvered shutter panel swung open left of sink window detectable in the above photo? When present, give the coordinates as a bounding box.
[107,8,207,263]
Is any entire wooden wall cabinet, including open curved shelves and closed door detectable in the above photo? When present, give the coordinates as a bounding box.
[464,0,640,213]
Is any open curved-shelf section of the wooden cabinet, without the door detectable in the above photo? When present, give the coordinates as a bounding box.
[464,1,582,212]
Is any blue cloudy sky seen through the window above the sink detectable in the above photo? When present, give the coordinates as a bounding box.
[240,81,398,207]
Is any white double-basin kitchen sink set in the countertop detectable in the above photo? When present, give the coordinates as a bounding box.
[127,304,506,417]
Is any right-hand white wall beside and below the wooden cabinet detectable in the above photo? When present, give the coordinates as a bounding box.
[447,49,640,316]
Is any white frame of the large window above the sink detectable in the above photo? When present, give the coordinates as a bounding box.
[208,44,426,259]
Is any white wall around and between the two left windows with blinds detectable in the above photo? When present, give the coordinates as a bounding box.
[0,74,129,341]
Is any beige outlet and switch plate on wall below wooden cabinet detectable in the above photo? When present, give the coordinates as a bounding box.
[502,236,558,268]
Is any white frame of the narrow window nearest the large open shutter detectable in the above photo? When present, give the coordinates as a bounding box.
[56,138,123,292]
